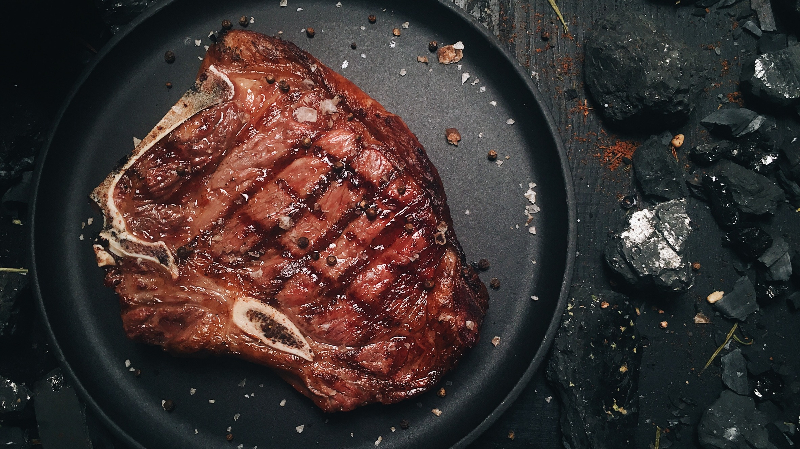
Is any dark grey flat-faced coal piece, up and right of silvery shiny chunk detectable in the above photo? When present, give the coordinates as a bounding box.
[715,160,786,215]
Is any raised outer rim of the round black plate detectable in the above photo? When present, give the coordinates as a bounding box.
[27,0,577,449]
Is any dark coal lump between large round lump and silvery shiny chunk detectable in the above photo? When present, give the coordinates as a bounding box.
[633,131,689,200]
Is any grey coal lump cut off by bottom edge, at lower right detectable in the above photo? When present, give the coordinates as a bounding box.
[697,390,769,449]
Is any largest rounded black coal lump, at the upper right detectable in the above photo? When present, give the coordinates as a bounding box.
[584,11,706,132]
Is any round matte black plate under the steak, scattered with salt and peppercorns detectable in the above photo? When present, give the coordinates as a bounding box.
[26,0,575,448]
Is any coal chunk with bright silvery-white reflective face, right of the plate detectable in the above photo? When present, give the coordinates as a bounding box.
[605,199,693,294]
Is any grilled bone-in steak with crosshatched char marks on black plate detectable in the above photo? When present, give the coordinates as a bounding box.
[92,31,488,411]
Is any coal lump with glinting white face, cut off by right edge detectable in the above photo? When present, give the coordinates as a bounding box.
[739,45,800,107]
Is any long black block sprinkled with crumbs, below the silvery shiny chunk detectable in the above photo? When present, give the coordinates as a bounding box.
[547,285,642,449]
